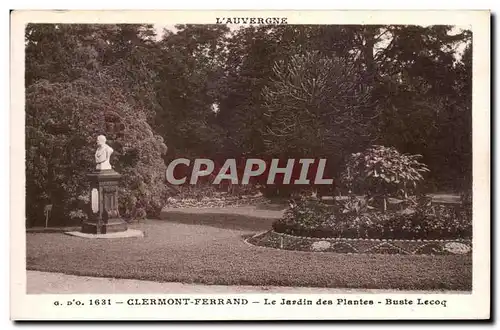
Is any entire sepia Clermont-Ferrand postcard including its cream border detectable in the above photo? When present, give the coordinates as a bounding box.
[10,11,491,321]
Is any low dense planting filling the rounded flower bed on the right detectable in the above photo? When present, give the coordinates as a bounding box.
[273,196,472,240]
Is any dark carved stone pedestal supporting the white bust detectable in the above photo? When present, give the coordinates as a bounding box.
[82,170,127,234]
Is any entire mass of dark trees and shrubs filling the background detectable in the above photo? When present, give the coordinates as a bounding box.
[25,24,472,224]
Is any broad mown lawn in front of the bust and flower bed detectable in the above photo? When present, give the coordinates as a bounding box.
[26,220,472,290]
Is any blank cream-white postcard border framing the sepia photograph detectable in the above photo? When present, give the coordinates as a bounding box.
[10,10,490,320]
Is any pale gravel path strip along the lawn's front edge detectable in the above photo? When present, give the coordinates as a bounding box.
[27,271,461,294]
